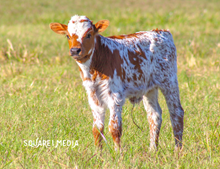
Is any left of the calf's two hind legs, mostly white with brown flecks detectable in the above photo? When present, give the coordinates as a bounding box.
[143,88,162,149]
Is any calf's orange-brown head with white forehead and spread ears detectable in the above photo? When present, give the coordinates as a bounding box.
[50,15,109,61]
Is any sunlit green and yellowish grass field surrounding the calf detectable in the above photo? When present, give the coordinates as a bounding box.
[0,0,220,168]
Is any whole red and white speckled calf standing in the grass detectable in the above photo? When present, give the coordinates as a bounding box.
[50,15,184,149]
